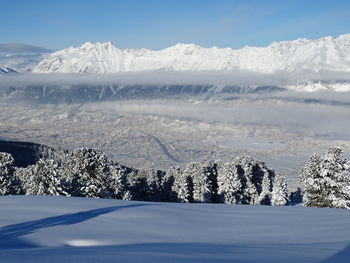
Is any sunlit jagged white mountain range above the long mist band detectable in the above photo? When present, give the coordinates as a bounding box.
[33,34,350,73]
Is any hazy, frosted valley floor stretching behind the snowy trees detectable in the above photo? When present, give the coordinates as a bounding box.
[0,94,350,190]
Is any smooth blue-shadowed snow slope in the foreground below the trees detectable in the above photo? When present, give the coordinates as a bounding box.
[0,196,350,263]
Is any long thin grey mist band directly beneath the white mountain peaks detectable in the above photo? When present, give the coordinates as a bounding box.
[0,71,350,87]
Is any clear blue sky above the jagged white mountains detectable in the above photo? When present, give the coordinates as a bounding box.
[0,0,350,50]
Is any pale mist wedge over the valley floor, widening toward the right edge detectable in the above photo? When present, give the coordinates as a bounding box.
[83,92,350,140]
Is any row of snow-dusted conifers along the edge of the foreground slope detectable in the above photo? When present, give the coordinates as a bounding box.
[0,148,350,208]
